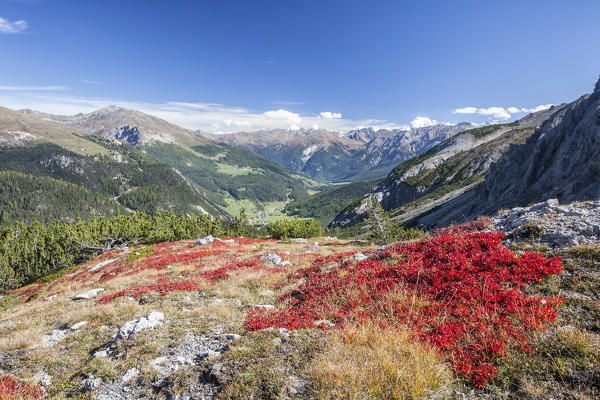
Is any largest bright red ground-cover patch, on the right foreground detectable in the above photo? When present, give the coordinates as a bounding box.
[246,232,562,387]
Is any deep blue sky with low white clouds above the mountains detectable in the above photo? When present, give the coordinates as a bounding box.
[0,0,600,132]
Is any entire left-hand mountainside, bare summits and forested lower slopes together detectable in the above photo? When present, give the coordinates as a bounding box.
[0,106,313,223]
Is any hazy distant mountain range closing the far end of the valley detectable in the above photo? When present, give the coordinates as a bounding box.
[215,123,472,181]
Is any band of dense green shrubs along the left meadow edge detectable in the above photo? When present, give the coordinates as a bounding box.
[0,212,222,293]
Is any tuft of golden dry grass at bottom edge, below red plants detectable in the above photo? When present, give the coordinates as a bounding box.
[311,325,452,400]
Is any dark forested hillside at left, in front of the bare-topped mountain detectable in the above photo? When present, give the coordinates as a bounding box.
[0,143,224,224]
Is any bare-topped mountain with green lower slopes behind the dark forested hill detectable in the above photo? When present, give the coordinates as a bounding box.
[15,106,312,219]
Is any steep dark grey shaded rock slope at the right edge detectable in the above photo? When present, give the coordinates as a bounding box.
[419,76,600,225]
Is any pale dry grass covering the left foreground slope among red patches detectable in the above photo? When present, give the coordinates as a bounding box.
[0,238,370,398]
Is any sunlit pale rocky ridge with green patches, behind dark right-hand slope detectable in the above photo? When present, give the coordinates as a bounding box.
[330,106,564,228]
